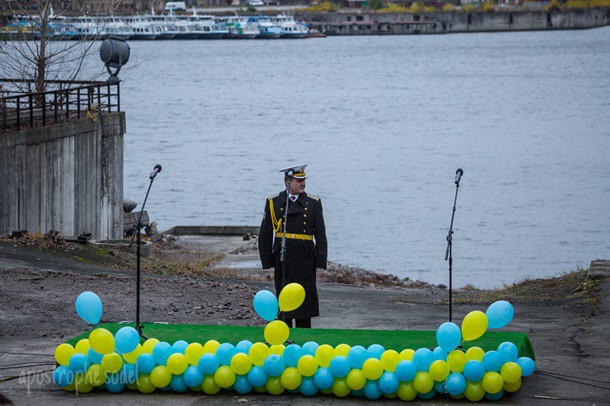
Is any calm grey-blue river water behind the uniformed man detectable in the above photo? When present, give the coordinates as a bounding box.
[121,27,610,287]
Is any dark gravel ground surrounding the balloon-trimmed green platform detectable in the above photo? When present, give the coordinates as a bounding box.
[0,236,610,405]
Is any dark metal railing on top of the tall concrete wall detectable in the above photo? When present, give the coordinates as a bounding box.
[0,79,121,132]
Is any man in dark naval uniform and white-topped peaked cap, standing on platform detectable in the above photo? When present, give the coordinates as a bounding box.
[258,164,327,328]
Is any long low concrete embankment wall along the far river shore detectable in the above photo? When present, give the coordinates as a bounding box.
[298,8,610,35]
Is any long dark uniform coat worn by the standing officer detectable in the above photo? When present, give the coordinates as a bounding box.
[258,191,327,319]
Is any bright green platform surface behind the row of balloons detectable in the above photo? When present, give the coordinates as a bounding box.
[68,323,535,360]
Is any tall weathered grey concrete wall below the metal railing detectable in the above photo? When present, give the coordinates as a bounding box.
[0,112,125,239]
